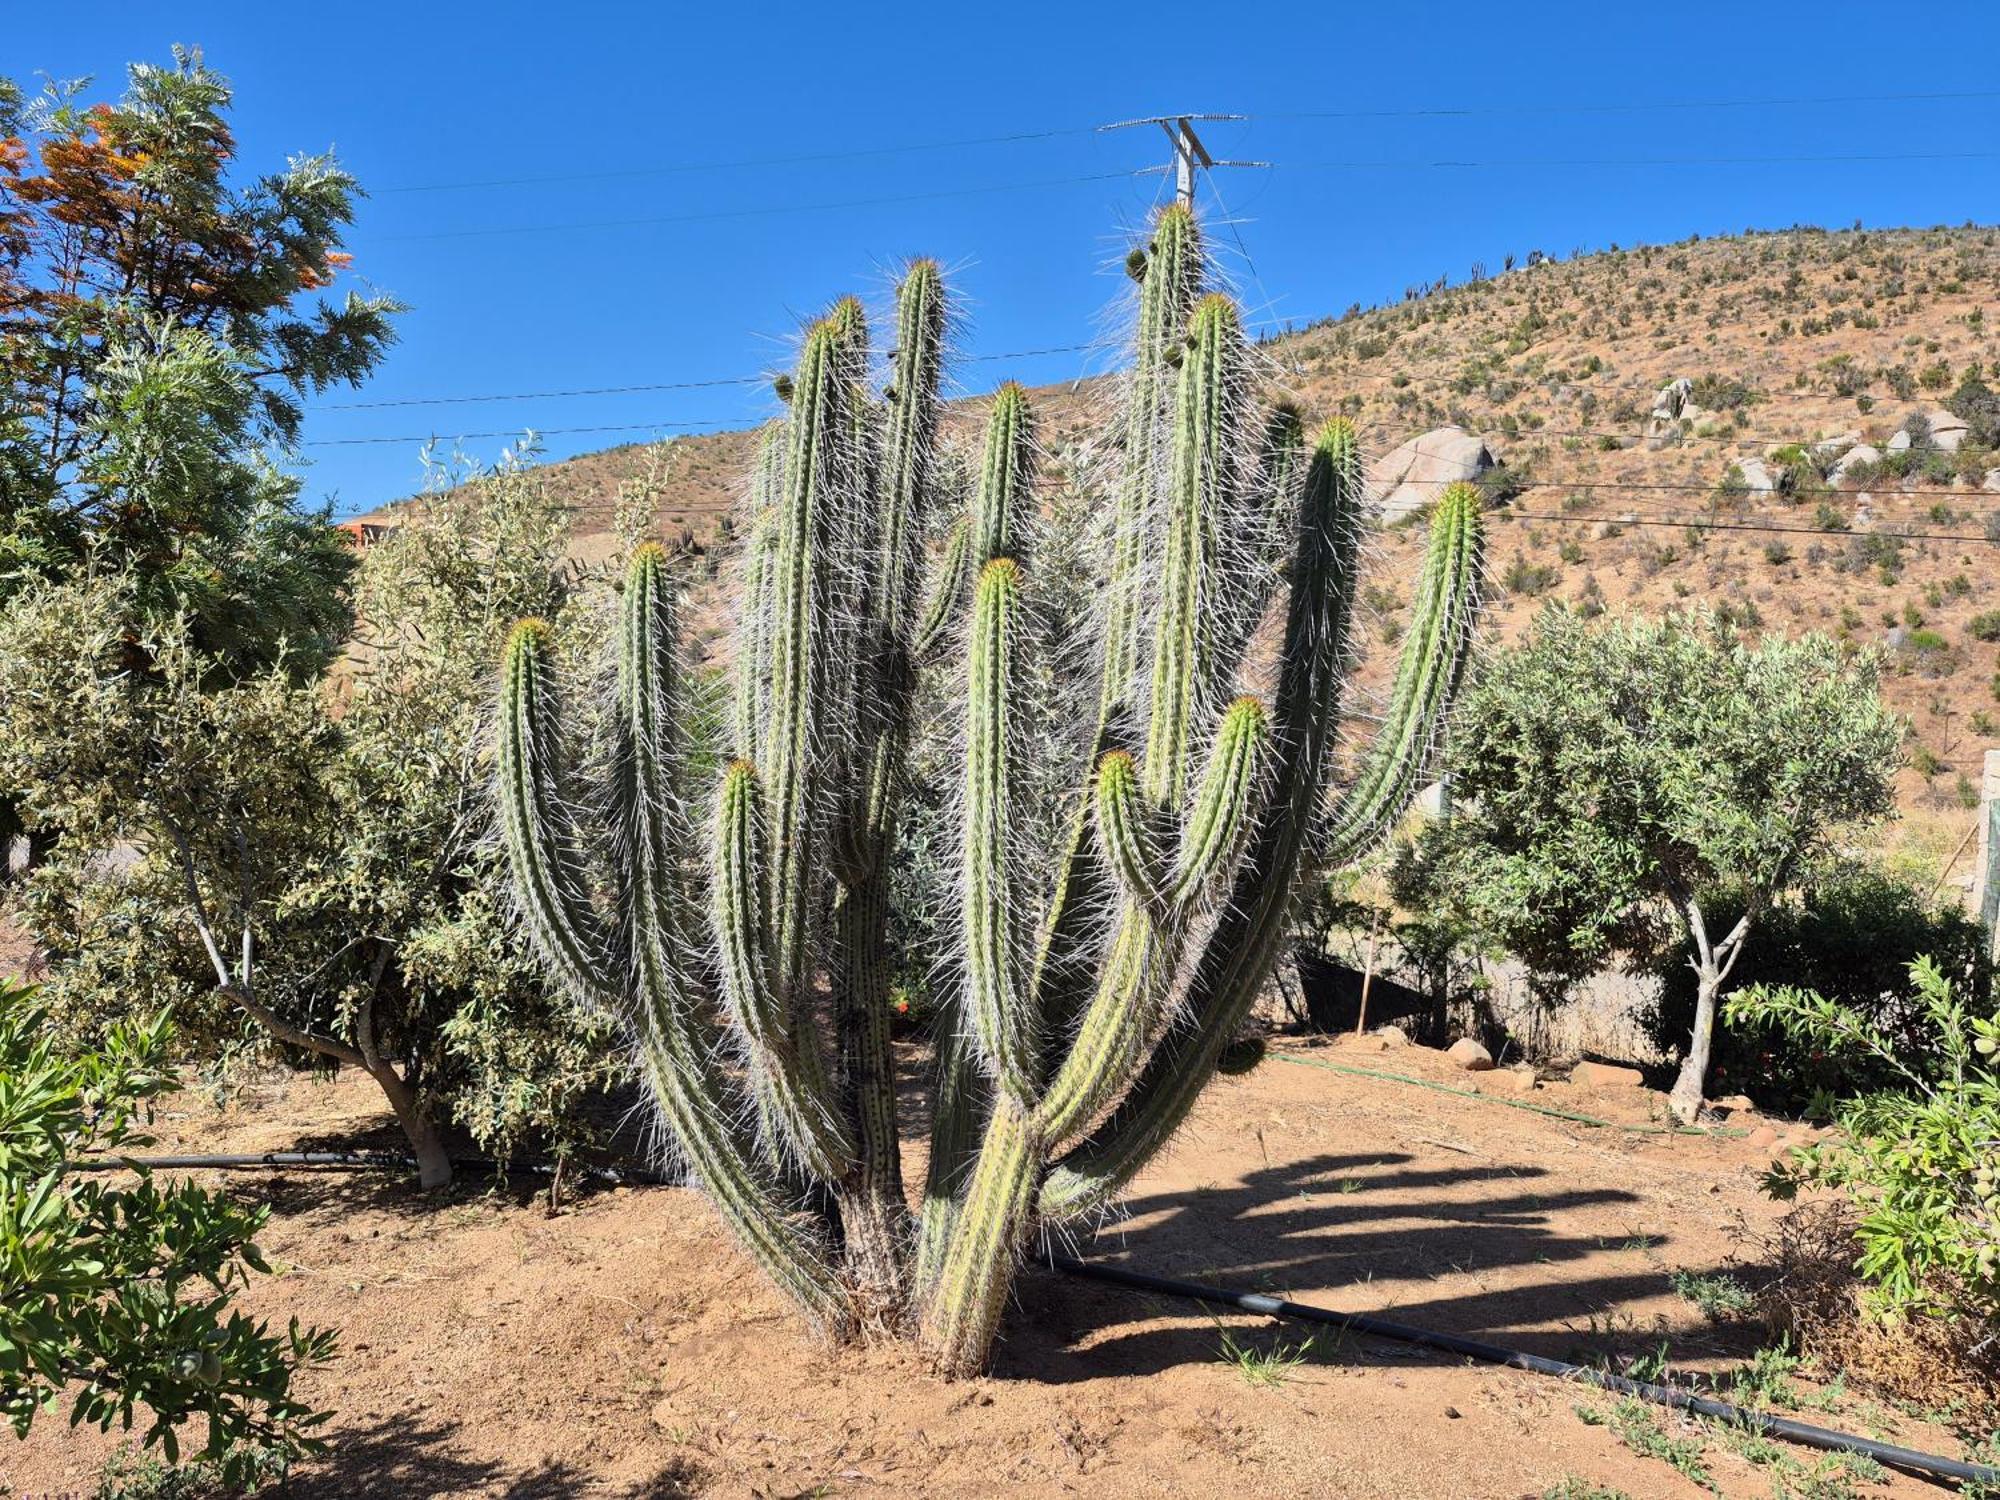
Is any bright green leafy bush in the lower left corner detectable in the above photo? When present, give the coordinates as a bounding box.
[0,982,334,1484]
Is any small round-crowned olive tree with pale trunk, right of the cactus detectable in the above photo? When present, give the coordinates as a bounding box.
[1398,606,1902,1120]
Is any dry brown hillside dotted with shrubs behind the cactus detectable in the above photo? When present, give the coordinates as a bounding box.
[368,228,2000,872]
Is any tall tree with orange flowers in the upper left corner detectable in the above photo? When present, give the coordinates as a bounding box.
[0,48,398,670]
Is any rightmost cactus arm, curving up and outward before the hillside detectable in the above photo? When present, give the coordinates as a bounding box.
[1330,484,1480,864]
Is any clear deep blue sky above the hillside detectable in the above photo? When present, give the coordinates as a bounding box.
[15,0,2000,512]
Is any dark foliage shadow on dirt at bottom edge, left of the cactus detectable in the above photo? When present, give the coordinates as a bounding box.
[282,1416,706,1500]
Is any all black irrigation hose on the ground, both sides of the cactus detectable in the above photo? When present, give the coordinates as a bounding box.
[54,1152,2000,1484]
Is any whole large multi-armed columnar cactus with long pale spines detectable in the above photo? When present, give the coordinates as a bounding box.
[500,208,1480,1374]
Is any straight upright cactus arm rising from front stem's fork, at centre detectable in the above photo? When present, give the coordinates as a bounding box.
[960,558,1038,1106]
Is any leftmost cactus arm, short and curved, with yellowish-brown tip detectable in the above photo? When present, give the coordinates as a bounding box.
[500,620,616,1000]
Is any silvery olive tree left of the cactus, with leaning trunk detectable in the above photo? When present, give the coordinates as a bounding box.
[0,456,622,1186]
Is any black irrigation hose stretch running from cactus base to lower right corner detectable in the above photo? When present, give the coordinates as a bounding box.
[1048,1254,2000,1484]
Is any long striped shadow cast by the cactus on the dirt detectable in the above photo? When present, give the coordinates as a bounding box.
[994,1152,1760,1380]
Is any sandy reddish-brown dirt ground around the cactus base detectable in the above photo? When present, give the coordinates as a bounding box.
[0,1016,1984,1500]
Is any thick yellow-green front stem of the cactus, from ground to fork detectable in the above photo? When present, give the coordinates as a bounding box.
[924,1094,1044,1376]
